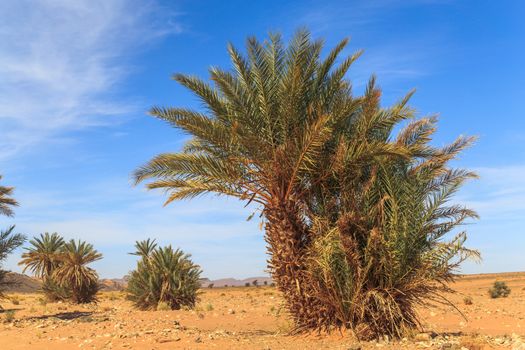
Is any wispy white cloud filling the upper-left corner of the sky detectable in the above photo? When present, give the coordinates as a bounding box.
[0,0,182,158]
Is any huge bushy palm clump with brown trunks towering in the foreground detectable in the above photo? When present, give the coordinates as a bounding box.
[135,31,478,337]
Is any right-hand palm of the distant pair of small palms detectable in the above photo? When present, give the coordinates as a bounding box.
[53,240,102,303]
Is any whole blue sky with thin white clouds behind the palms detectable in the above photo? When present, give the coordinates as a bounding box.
[0,0,525,278]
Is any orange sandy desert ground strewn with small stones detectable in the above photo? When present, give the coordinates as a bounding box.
[0,273,525,350]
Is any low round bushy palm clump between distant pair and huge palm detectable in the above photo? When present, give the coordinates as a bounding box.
[127,239,201,310]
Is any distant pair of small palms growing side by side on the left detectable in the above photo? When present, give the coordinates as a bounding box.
[19,232,102,304]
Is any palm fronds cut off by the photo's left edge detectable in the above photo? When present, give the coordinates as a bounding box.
[0,175,26,299]
